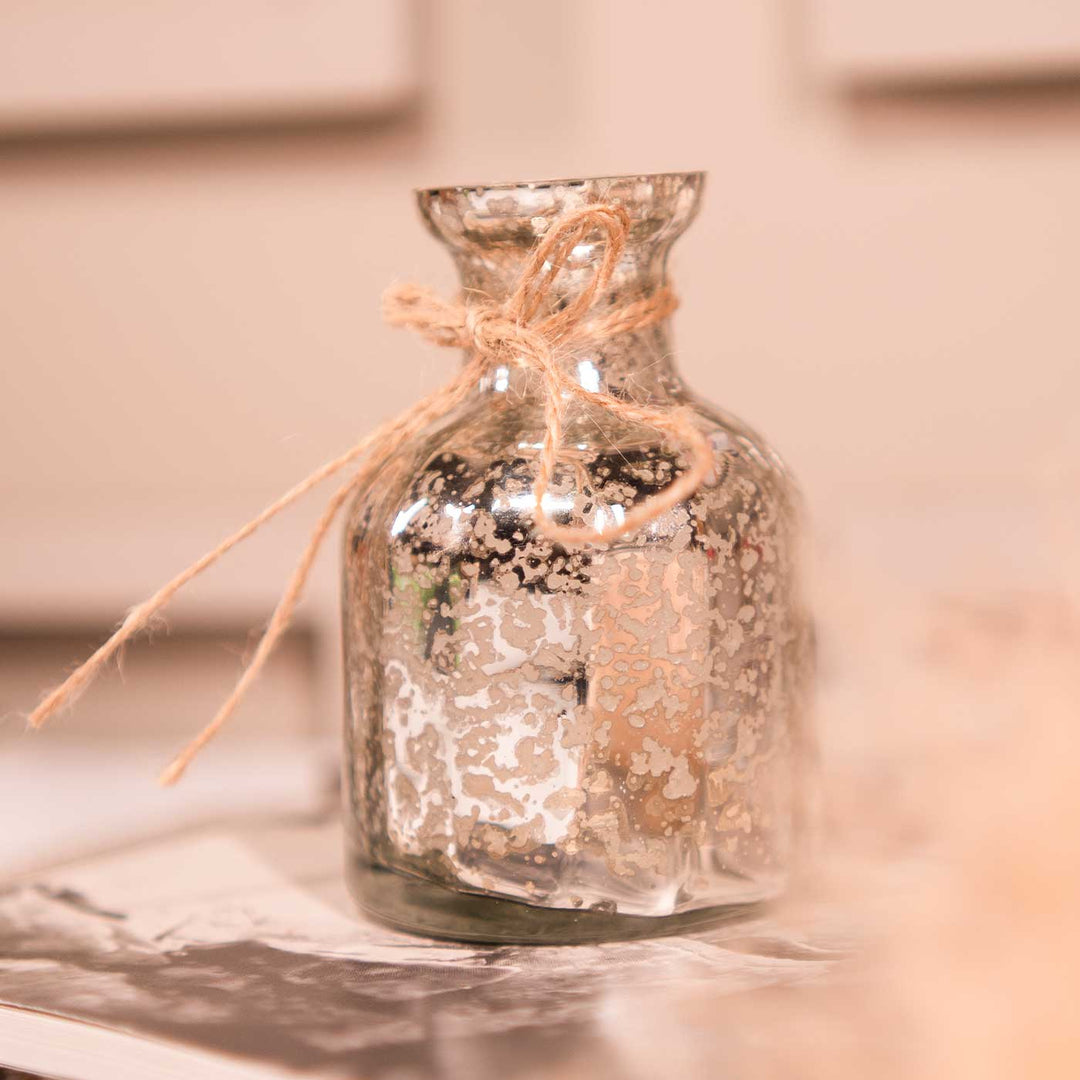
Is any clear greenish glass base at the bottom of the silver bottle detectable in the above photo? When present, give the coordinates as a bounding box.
[348,859,765,945]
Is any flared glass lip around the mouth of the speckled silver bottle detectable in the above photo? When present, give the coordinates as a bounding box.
[416,172,705,247]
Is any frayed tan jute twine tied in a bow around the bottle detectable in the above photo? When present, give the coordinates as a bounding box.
[29,205,712,784]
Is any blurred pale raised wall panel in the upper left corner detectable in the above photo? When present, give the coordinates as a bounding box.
[0,0,417,135]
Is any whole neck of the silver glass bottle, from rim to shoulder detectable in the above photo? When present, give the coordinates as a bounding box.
[419,173,702,401]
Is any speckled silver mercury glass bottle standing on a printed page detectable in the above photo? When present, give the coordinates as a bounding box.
[343,173,808,943]
